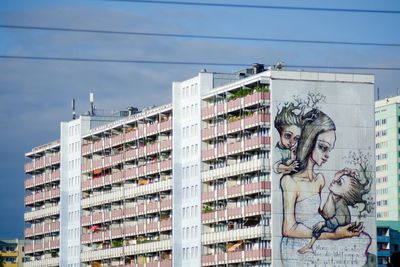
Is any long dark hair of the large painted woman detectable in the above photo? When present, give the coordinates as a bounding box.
[296,109,336,171]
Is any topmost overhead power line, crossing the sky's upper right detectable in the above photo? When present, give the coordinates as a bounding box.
[107,0,400,14]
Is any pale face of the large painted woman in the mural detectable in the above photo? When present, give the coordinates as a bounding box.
[311,130,336,166]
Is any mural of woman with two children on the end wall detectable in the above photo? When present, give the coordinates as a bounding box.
[273,92,376,266]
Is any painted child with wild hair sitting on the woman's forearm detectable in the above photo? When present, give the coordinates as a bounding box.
[298,169,366,254]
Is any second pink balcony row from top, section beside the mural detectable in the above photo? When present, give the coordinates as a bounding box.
[201,113,271,141]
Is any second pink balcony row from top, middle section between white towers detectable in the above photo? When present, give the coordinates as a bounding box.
[82,148,172,173]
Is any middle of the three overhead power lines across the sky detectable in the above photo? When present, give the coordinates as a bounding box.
[0,24,400,47]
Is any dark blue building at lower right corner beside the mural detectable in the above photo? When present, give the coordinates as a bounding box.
[376,221,400,267]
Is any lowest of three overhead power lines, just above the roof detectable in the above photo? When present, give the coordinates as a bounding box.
[0,55,400,71]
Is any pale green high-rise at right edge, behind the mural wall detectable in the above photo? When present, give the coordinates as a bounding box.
[375,96,400,221]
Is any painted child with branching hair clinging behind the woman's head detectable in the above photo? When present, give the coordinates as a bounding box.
[273,104,302,174]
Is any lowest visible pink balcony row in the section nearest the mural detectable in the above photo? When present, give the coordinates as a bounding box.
[202,249,271,266]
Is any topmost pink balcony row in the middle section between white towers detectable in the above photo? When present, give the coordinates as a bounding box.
[82,119,172,155]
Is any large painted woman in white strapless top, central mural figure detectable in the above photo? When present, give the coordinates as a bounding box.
[281,109,365,266]
